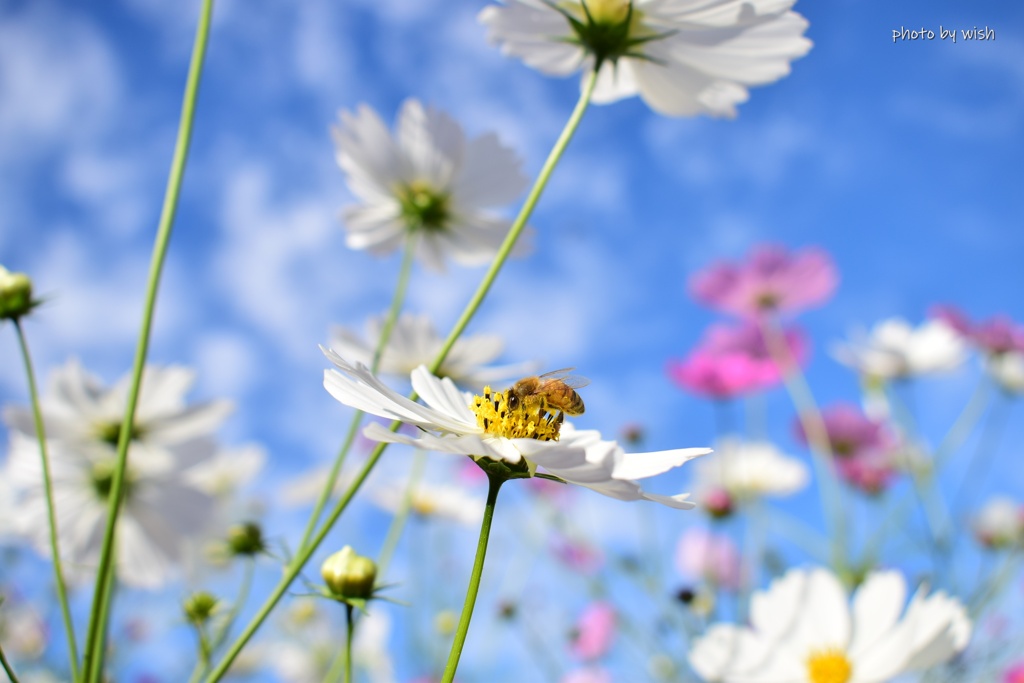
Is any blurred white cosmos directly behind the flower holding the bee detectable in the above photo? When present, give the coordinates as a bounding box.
[331,313,536,389]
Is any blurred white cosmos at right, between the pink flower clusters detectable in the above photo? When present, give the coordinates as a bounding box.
[831,317,967,379]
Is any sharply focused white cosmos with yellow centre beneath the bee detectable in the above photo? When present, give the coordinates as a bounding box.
[324,349,710,509]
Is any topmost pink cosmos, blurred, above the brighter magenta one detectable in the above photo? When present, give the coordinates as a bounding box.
[690,245,839,318]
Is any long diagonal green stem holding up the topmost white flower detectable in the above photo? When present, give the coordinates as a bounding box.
[200,66,597,683]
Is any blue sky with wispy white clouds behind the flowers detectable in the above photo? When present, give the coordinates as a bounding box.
[0,0,1024,679]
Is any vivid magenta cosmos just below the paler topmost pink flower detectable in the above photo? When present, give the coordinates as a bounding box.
[668,324,807,398]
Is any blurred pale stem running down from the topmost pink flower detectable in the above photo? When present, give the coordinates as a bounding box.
[761,318,846,570]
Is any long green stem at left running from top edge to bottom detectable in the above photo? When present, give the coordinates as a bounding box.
[83,0,213,683]
